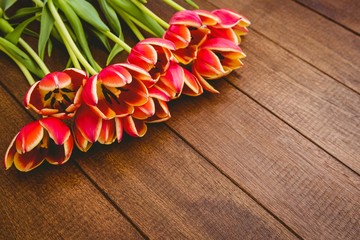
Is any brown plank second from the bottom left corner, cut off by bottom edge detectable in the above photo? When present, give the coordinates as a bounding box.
[79,124,295,239]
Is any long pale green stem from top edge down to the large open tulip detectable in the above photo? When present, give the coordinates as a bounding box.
[47,0,97,75]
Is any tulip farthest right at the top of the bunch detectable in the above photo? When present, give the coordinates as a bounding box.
[209,9,250,45]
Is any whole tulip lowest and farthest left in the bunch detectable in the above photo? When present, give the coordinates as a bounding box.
[4,117,74,172]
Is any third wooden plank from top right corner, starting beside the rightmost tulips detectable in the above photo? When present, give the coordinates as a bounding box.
[235,32,360,173]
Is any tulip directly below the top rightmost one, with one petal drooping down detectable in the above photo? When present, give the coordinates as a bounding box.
[192,38,246,93]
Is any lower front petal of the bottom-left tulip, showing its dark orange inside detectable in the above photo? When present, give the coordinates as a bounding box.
[14,148,46,172]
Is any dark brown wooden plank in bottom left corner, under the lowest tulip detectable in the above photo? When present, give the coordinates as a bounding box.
[0,86,141,239]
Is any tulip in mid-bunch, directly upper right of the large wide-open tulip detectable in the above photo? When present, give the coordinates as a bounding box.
[127,38,175,82]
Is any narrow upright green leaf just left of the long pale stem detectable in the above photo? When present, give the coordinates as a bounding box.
[38,4,54,59]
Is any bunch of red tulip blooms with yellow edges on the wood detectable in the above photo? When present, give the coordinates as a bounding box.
[0,0,250,171]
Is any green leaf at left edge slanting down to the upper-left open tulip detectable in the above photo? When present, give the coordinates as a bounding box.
[0,37,44,78]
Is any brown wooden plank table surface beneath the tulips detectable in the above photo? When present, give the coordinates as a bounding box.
[0,0,360,239]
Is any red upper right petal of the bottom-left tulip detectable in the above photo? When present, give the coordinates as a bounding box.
[39,117,71,145]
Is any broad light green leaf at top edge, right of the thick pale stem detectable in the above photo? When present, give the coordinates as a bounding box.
[65,0,110,32]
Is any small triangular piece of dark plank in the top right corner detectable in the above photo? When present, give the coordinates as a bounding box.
[296,0,360,33]
